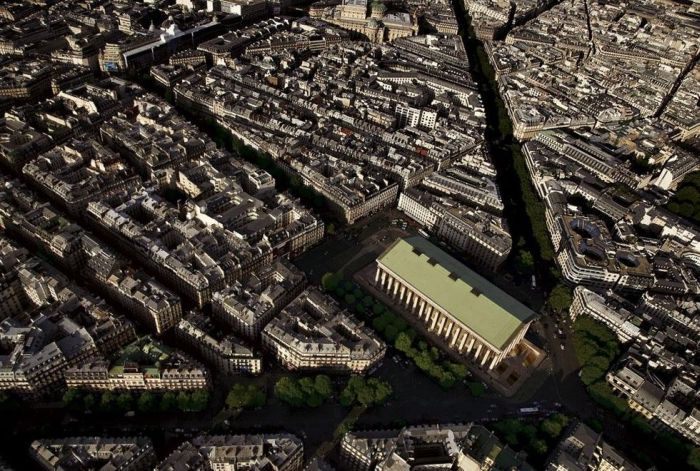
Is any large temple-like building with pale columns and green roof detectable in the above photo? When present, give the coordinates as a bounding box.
[374,237,536,370]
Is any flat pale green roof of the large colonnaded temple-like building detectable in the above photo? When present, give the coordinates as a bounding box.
[378,237,535,348]
